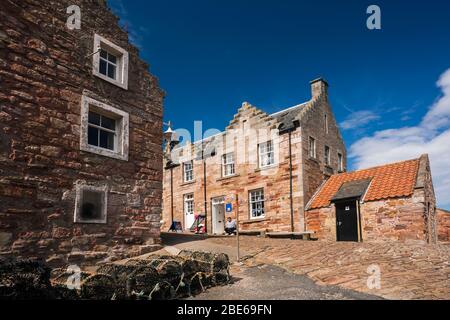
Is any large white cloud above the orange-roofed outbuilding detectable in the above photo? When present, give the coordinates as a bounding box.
[349,69,450,208]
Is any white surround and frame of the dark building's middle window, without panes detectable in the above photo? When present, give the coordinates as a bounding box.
[80,96,129,161]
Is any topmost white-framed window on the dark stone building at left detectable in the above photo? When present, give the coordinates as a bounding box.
[92,34,129,90]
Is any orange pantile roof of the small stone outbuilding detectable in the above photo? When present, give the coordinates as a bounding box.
[308,159,420,210]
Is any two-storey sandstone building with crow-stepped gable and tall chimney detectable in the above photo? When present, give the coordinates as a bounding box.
[162,79,346,234]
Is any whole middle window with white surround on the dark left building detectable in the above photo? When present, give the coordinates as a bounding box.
[80,96,129,161]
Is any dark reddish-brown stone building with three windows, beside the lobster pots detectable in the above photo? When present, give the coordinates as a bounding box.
[0,0,164,264]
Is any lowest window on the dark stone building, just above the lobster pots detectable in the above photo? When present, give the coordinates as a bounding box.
[74,185,108,224]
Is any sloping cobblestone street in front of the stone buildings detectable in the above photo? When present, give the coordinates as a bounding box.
[162,232,450,299]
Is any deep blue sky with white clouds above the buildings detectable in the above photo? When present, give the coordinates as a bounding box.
[108,0,450,208]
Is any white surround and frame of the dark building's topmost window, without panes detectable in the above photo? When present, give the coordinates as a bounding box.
[92,34,129,90]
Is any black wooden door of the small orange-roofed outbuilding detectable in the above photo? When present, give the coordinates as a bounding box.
[336,200,358,242]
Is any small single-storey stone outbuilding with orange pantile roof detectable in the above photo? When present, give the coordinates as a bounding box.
[306,155,437,243]
